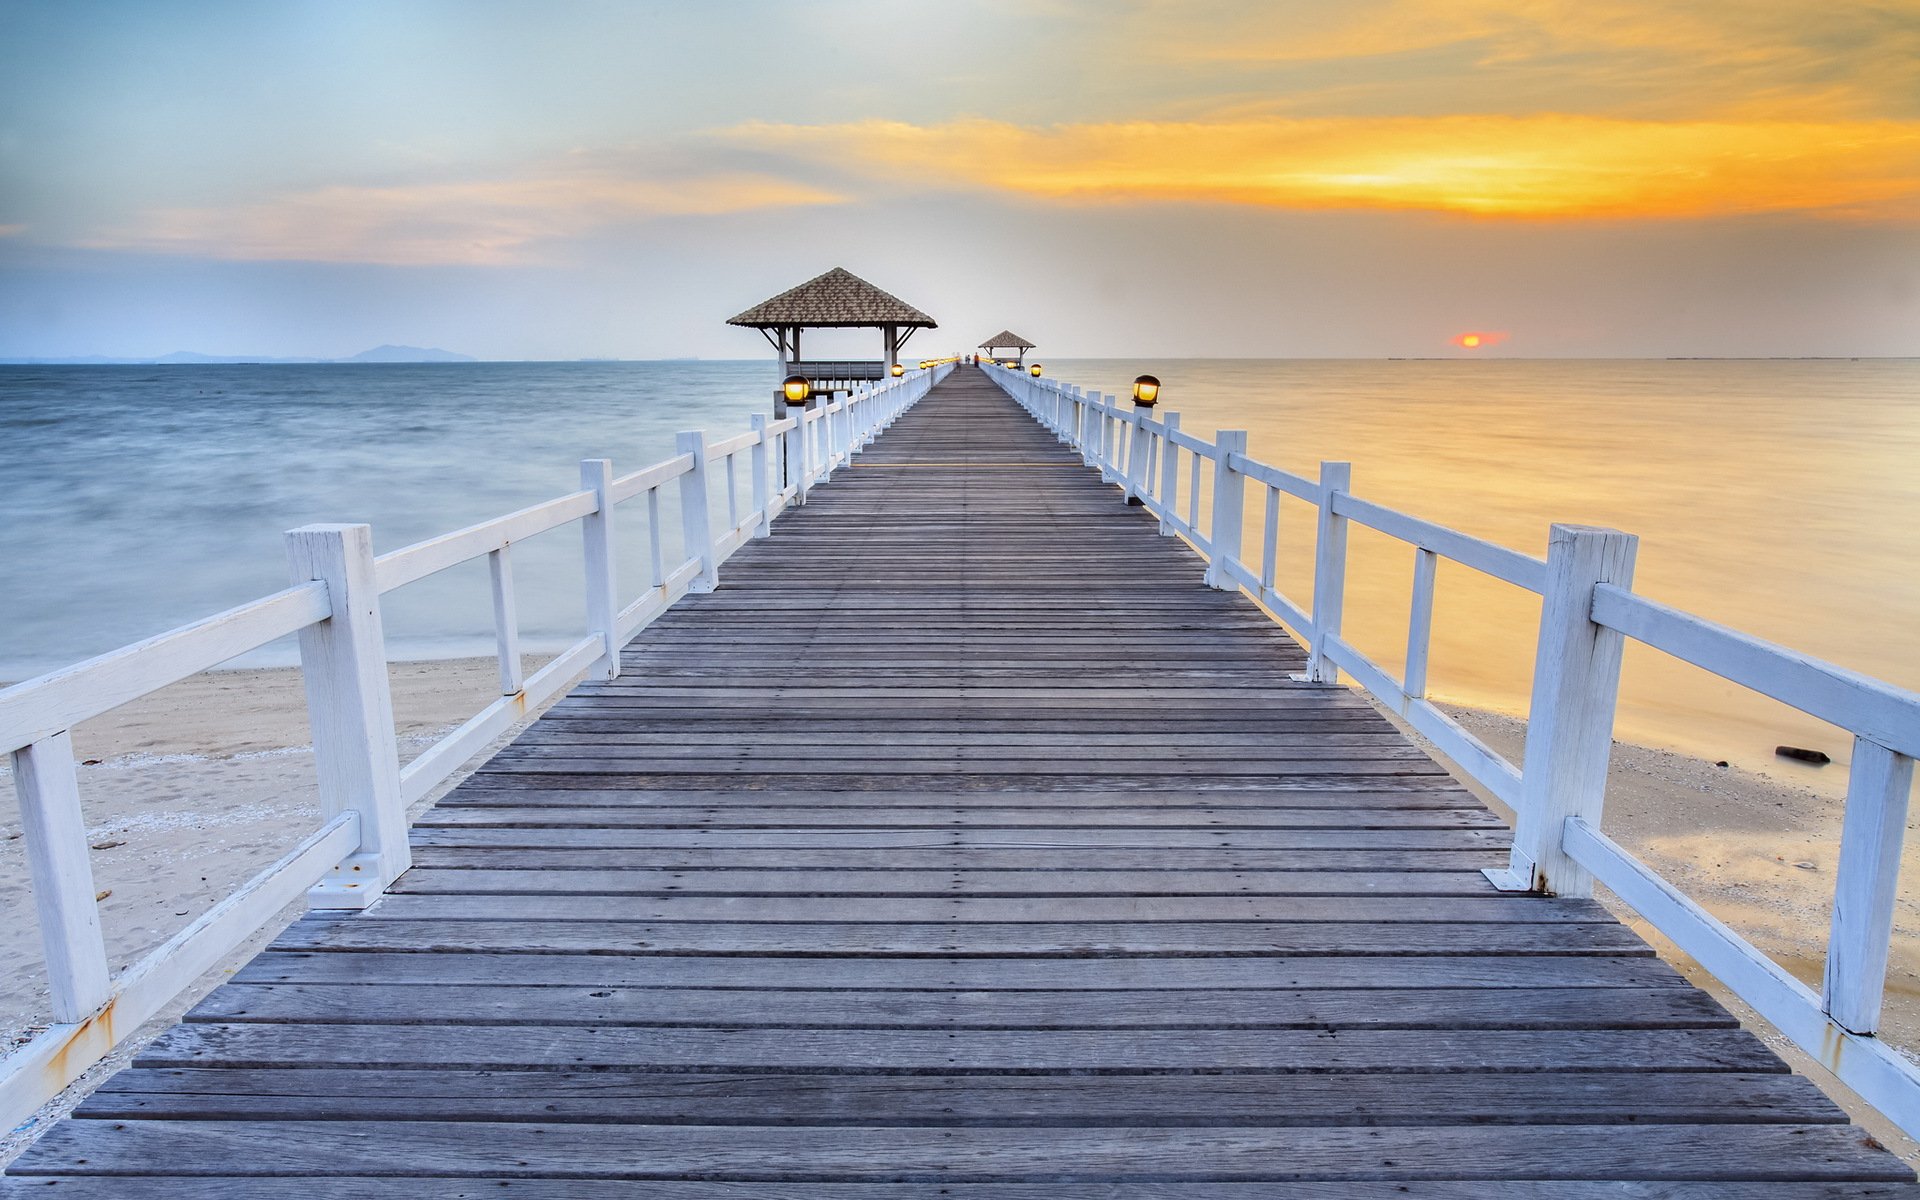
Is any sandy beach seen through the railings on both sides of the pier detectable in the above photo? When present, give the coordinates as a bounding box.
[0,660,1920,1160]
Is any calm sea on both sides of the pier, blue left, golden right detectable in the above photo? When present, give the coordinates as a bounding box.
[0,359,1920,766]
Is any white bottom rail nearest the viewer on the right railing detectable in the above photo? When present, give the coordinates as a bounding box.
[1563,818,1920,1137]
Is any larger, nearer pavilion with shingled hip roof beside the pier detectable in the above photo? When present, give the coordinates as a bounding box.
[728,267,939,392]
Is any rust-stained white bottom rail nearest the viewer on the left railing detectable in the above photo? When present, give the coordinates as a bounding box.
[0,812,361,1129]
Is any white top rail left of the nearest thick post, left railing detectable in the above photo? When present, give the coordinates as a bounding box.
[0,584,332,751]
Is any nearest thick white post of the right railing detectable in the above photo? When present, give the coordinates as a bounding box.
[1482,524,1640,897]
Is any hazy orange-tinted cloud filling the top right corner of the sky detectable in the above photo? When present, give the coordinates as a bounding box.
[1116,0,1920,119]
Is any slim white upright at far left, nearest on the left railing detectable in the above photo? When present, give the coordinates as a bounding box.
[13,730,111,1023]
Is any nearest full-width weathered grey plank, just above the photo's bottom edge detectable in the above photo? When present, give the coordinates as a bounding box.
[25,1119,1907,1183]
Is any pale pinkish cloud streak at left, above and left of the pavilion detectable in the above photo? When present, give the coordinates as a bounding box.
[83,171,841,265]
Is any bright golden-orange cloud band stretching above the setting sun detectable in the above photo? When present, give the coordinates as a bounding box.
[724,115,1920,221]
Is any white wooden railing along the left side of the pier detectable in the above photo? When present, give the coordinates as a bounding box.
[0,365,952,1129]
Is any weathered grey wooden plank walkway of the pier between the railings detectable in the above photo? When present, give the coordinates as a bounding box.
[0,371,1916,1200]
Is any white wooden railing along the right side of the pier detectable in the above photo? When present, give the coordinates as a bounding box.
[983,360,1920,1137]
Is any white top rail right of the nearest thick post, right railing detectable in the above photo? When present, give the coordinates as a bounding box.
[1594,586,1920,758]
